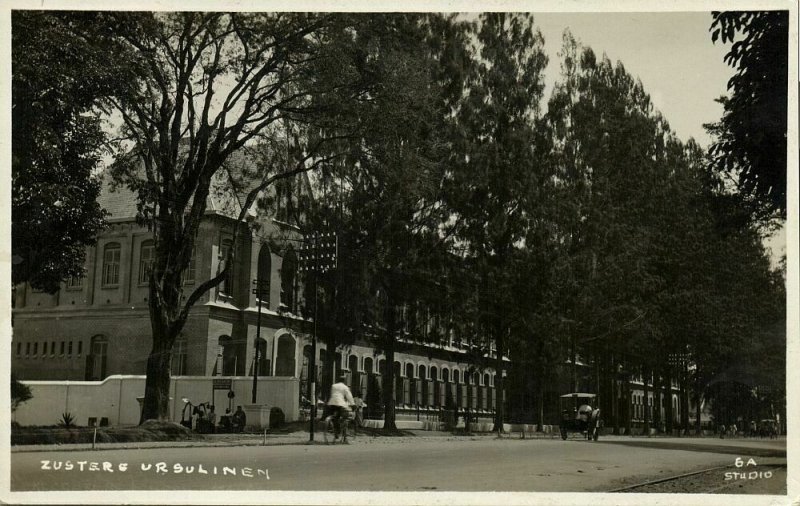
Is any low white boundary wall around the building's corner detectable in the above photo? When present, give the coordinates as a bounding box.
[12,375,300,425]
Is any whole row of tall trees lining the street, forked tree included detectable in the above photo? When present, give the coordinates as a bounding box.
[14,12,782,430]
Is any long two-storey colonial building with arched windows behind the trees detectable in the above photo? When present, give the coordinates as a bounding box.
[12,159,496,418]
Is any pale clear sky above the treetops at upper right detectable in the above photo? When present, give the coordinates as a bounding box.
[534,12,733,147]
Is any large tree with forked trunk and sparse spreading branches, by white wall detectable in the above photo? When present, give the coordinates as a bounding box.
[97,12,362,419]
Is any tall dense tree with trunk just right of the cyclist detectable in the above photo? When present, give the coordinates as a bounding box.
[304,14,472,431]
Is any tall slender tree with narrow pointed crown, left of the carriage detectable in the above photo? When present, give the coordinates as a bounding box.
[447,13,547,430]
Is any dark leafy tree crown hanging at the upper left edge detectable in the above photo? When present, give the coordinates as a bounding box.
[11,11,135,293]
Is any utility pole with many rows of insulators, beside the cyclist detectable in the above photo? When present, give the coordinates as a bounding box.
[298,232,339,441]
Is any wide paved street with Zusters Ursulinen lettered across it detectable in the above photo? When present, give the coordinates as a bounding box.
[11,433,786,494]
